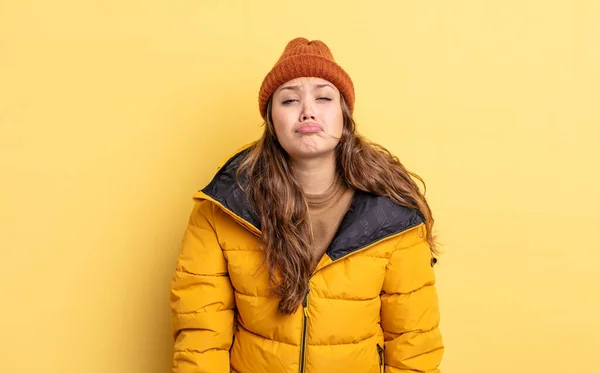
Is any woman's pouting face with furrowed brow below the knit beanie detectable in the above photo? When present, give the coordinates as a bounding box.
[271,77,344,159]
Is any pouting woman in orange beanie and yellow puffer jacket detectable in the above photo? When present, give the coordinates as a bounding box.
[171,38,443,373]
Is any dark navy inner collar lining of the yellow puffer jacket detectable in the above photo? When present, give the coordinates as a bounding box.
[201,148,425,260]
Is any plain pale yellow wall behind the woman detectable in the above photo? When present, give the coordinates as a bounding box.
[0,0,600,373]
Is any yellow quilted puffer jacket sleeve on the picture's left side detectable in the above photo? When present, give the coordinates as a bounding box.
[171,201,235,373]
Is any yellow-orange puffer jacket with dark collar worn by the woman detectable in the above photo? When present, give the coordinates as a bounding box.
[171,150,444,373]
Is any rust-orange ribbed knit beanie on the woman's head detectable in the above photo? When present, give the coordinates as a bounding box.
[258,38,354,120]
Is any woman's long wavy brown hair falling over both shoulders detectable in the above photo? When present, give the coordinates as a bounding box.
[238,95,437,314]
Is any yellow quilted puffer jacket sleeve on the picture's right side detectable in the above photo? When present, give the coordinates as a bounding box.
[381,225,444,373]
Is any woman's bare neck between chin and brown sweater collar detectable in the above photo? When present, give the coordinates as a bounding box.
[292,153,336,195]
